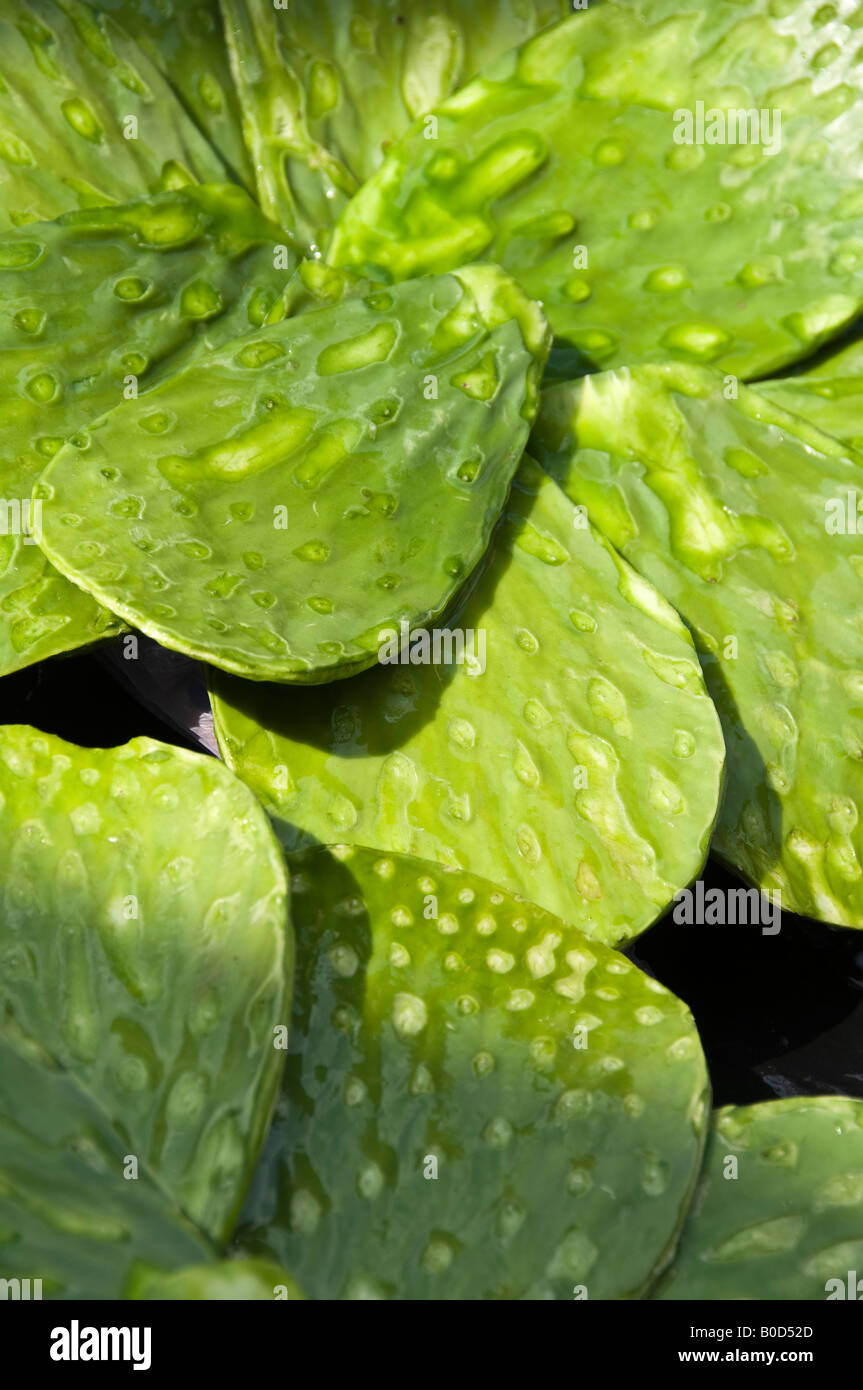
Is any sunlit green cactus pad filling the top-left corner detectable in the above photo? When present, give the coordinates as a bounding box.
[0,0,228,227]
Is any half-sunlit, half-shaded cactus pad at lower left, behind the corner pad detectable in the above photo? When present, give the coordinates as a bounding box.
[0,726,293,1251]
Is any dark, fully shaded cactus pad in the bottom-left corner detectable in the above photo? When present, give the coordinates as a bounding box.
[0,1028,214,1298]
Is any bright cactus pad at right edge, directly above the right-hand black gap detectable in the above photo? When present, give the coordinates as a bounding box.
[531,363,863,927]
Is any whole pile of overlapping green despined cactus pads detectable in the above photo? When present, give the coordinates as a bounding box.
[0,0,863,1300]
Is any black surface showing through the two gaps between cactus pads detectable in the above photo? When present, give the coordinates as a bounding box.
[0,644,863,1105]
